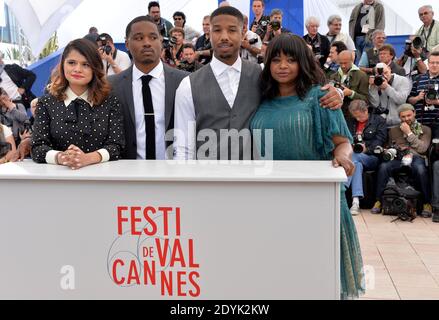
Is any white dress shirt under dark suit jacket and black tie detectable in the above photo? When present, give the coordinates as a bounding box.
[133,61,167,160]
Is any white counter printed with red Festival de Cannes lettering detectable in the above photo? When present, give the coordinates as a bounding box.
[0,161,346,300]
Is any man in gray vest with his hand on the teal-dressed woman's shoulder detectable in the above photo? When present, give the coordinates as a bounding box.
[174,7,342,160]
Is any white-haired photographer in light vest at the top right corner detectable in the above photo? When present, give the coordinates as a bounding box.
[416,5,439,53]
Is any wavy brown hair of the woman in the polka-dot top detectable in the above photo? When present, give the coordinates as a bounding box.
[49,39,111,105]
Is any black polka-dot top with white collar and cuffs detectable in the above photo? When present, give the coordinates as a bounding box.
[32,95,125,163]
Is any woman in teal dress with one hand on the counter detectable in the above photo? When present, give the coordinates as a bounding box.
[250,34,364,299]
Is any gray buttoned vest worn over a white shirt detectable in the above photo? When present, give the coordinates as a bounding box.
[190,60,261,160]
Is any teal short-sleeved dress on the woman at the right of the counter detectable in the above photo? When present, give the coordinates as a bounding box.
[250,86,364,299]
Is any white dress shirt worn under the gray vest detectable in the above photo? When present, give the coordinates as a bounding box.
[174,56,242,160]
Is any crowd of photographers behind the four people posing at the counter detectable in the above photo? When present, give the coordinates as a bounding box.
[0,0,439,222]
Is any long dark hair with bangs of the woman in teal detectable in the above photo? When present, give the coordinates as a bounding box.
[260,33,326,100]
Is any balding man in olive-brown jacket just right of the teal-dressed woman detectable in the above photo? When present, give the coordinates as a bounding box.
[330,51,369,123]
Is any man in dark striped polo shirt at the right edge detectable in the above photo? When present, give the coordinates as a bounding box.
[408,52,439,131]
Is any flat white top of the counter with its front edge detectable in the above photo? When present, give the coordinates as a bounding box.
[0,161,347,183]
